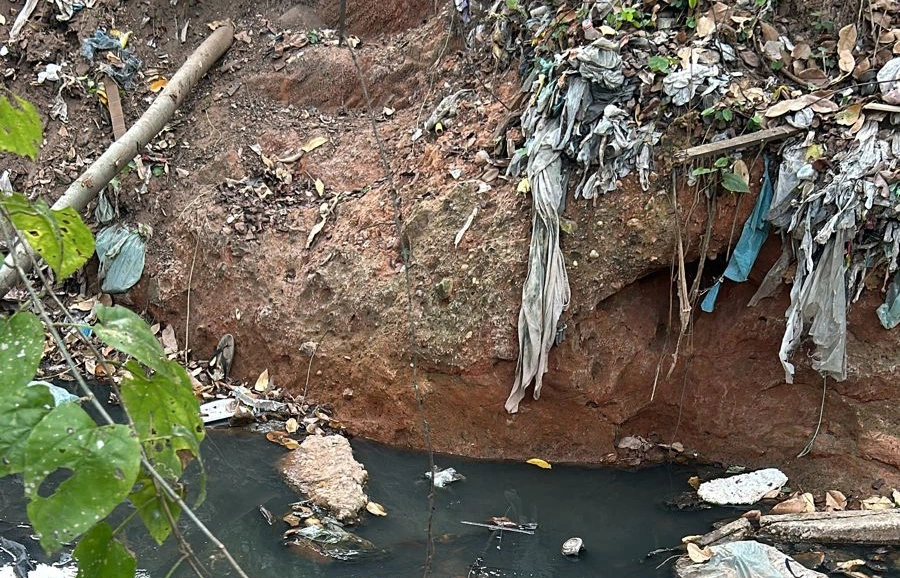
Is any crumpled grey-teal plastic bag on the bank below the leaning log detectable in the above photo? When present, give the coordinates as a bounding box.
[96,224,147,293]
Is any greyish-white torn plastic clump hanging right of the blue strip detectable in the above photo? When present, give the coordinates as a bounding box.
[769,120,897,383]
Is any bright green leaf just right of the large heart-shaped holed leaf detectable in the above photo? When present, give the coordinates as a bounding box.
[121,361,205,481]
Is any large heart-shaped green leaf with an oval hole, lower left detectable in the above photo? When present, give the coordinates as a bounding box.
[24,403,141,552]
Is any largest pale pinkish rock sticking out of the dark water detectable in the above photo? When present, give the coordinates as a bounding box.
[281,435,369,522]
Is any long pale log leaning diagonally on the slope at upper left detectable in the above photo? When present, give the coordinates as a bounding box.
[0,24,234,297]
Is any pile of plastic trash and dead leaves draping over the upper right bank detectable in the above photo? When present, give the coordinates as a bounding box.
[465,0,900,413]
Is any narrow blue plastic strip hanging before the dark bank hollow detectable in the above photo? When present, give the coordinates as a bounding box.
[700,157,772,313]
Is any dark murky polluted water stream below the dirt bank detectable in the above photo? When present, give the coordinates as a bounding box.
[0,429,739,578]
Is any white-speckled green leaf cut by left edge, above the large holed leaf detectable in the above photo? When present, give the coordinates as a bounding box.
[0,311,44,392]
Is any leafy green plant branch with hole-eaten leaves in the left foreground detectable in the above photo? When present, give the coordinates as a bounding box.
[0,91,248,578]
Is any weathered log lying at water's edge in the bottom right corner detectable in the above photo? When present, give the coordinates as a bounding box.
[756,508,900,546]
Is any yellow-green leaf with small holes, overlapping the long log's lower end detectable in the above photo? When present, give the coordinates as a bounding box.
[0,193,94,280]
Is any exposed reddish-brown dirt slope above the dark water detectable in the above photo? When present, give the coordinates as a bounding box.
[0,0,900,489]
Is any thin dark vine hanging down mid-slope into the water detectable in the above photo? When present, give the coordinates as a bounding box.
[347,44,434,578]
